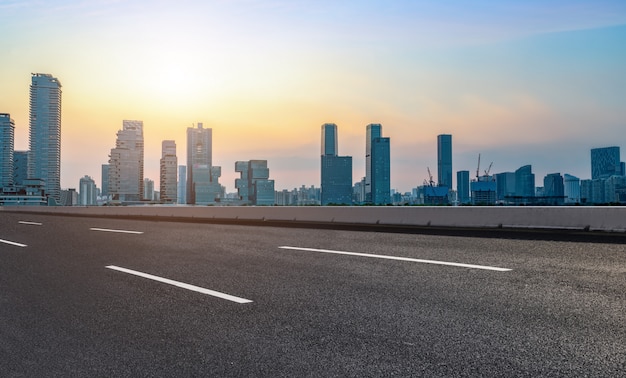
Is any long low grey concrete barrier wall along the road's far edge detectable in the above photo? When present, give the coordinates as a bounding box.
[0,206,626,232]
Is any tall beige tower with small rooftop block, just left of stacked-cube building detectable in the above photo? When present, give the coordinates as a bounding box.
[187,123,213,204]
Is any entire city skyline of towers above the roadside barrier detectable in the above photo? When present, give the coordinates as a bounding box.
[0,73,626,206]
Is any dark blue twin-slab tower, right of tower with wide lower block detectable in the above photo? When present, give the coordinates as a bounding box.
[365,123,391,205]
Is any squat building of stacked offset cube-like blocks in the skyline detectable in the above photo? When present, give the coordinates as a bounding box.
[235,160,275,206]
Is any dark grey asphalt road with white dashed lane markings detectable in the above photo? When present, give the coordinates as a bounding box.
[0,213,626,377]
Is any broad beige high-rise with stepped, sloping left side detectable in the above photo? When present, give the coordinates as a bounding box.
[109,120,144,201]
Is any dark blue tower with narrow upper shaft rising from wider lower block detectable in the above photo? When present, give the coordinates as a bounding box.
[321,123,352,205]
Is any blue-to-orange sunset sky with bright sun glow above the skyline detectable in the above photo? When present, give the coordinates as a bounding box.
[0,0,626,192]
